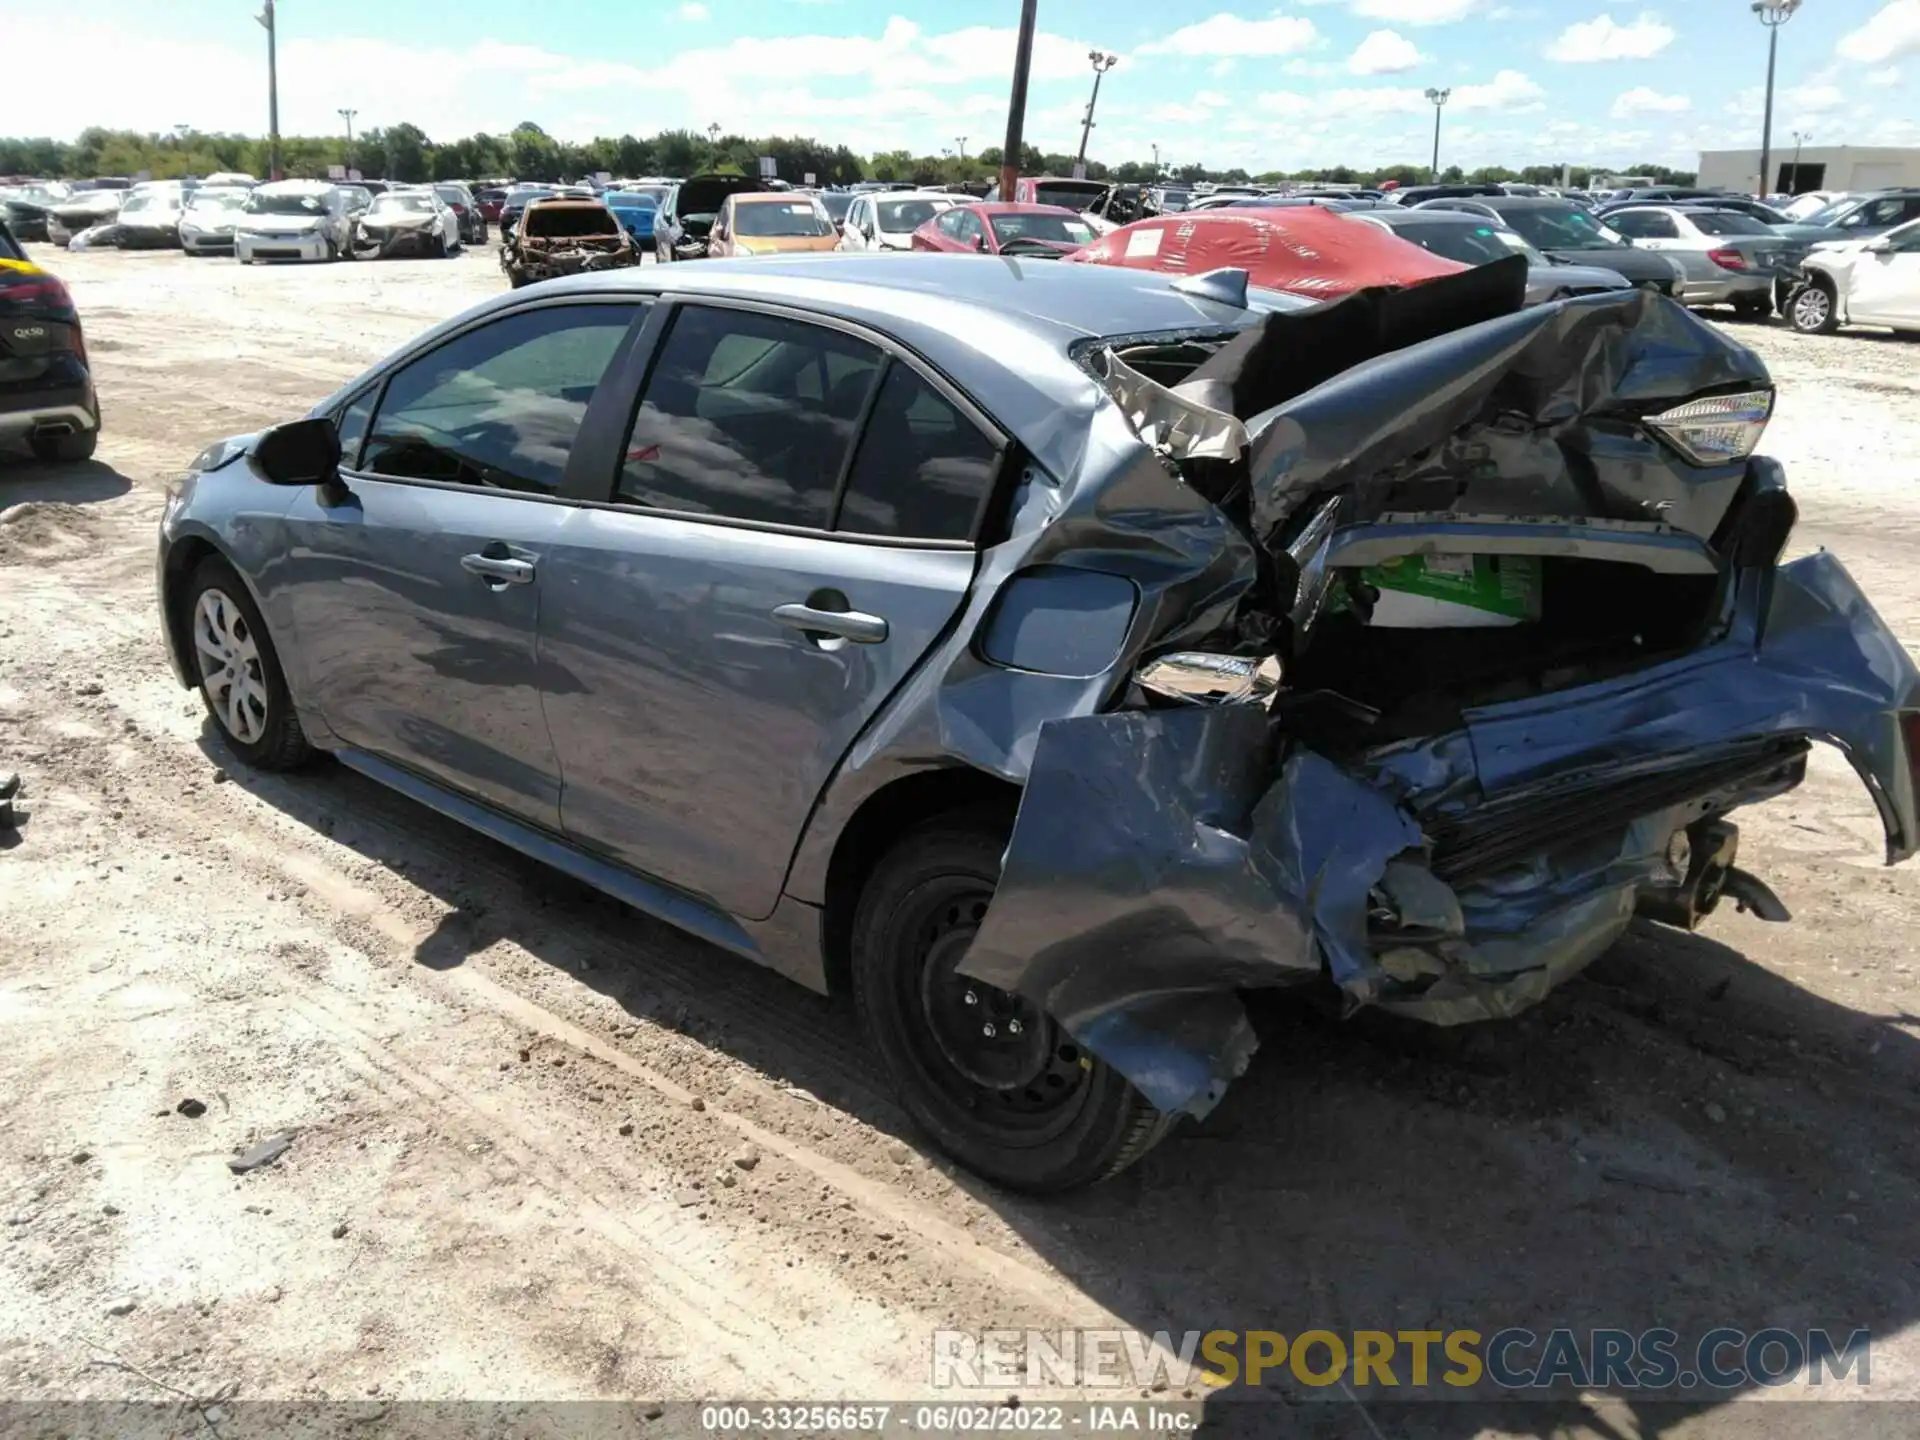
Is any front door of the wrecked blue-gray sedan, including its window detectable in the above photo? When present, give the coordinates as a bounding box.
[284,303,639,828]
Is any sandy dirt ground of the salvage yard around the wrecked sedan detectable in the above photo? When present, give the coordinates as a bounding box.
[0,248,1920,1436]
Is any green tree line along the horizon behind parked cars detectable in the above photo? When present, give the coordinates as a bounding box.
[0,121,1693,184]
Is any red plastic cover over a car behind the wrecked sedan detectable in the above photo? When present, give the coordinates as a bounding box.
[1066,205,1469,300]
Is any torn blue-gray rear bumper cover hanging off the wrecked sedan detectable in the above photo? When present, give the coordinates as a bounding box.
[962,553,1920,1116]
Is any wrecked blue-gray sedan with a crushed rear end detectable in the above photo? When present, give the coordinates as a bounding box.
[159,255,1920,1190]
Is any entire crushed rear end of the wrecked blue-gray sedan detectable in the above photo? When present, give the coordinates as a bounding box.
[962,259,1920,1116]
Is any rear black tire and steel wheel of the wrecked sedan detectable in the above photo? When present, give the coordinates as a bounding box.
[852,812,1171,1194]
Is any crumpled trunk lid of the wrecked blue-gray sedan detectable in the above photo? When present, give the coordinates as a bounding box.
[1244,284,1772,545]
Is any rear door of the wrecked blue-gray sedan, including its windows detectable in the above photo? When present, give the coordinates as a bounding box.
[541,301,1004,918]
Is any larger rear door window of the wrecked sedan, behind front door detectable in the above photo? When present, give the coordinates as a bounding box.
[618,305,881,530]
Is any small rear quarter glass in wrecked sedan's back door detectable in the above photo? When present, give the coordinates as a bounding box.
[835,363,1000,540]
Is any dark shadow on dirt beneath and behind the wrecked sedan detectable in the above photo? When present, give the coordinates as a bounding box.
[204,730,1920,1440]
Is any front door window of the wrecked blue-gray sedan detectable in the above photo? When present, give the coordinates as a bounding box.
[361,305,639,495]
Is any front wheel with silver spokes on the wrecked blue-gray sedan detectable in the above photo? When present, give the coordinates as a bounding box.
[180,559,313,770]
